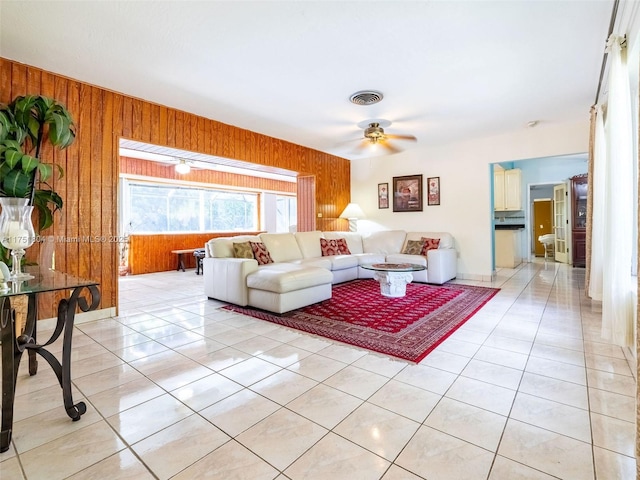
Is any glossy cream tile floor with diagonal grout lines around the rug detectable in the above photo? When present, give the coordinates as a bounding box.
[0,262,635,480]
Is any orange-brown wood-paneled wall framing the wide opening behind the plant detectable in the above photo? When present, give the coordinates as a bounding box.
[0,57,350,316]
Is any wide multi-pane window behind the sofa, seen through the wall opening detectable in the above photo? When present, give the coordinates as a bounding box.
[124,182,258,233]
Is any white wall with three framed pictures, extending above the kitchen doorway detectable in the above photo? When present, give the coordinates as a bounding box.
[351,117,589,279]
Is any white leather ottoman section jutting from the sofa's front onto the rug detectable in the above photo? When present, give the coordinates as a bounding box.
[247,263,333,313]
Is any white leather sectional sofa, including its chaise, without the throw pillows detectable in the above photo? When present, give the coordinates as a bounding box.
[202,230,457,313]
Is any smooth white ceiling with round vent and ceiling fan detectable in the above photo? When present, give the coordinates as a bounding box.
[0,0,613,159]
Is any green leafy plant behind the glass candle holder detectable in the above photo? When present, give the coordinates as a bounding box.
[0,95,75,264]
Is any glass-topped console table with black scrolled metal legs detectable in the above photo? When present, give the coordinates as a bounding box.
[0,267,100,452]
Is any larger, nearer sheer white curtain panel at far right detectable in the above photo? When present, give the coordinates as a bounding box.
[594,35,634,346]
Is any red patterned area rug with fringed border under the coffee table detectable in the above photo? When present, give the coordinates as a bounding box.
[224,280,499,362]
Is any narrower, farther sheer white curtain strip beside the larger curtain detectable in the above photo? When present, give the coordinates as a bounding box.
[589,105,607,302]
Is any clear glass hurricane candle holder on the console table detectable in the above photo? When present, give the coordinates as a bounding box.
[0,197,36,280]
